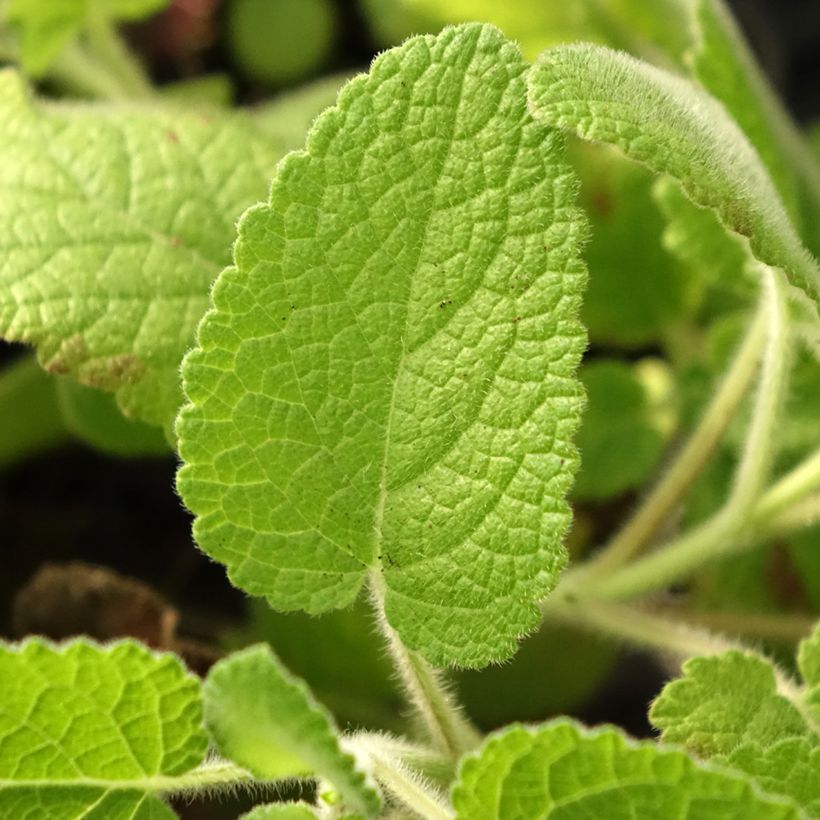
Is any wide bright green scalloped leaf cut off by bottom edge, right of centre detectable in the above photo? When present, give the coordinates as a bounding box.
[452,719,802,820]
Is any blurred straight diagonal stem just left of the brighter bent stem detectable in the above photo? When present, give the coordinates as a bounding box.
[568,300,768,576]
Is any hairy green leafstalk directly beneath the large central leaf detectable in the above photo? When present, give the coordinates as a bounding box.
[371,572,481,760]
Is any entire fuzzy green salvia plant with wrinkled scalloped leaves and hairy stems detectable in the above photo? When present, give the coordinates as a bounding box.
[0,0,820,820]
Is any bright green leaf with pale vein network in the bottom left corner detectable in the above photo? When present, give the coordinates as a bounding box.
[0,639,208,820]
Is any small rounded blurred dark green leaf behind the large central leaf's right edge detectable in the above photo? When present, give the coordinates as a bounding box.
[573,359,664,500]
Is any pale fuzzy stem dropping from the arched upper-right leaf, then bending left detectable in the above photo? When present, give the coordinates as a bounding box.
[562,271,788,600]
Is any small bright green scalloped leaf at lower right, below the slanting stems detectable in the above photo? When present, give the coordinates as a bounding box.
[649,651,809,757]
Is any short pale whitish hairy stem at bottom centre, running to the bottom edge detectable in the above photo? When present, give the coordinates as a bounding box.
[345,735,455,820]
